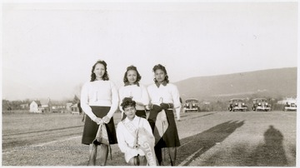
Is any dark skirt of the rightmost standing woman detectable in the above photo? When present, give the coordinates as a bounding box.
[148,109,180,148]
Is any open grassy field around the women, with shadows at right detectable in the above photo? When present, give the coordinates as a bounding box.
[2,111,296,166]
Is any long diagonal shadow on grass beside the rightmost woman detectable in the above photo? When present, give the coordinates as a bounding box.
[177,121,244,166]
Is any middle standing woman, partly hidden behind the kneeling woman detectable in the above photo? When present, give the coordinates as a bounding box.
[119,65,149,119]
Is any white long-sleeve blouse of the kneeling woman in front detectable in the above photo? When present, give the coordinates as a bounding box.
[117,116,154,162]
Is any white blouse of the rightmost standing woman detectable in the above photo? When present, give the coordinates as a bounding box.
[147,83,181,108]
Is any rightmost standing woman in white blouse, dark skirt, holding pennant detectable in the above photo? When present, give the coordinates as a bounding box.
[148,64,180,166]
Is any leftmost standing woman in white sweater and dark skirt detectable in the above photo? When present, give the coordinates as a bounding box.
[80,60,119,165]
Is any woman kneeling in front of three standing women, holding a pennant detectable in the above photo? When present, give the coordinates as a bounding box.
[117,98,157,166]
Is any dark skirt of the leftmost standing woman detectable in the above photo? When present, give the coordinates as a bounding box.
[81,106,118,145]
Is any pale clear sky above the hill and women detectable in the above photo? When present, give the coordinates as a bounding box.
[2,1,298,100]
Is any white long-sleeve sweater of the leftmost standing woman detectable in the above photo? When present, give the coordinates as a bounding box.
[80,81,119,120]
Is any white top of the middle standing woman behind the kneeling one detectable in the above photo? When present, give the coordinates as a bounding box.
[119,84,149,111]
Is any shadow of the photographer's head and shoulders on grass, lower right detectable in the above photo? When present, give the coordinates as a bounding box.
[203,125,295,166]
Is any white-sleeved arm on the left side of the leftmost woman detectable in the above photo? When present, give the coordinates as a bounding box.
[80,84,97,121]
